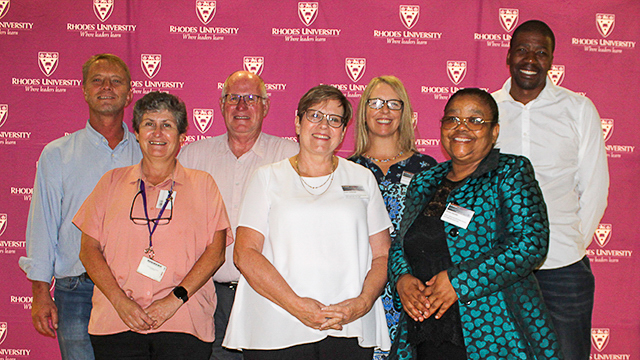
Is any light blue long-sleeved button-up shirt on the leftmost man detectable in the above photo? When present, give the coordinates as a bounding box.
[19,121,142,283]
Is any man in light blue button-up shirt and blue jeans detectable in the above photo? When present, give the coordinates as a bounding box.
[19,54,142,360]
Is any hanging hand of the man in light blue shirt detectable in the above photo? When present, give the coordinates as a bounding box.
[31,281,58,338]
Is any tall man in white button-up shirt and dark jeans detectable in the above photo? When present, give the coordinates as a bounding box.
[493,20,609,359]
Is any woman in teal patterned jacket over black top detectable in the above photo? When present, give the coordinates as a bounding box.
[389,89,562,359]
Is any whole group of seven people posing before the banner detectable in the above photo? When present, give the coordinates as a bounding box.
[20,20,608,360]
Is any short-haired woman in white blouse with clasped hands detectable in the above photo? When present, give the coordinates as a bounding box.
[223,85,391,360]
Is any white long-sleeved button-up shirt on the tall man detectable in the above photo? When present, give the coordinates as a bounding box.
[493,79,609,269]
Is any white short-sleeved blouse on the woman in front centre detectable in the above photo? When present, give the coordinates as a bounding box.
[223,158,393,350]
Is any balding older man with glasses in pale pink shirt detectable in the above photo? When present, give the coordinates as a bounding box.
[178,71,298,360]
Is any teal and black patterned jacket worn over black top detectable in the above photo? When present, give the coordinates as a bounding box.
[389,149,562,359]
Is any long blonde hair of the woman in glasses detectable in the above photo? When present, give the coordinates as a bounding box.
[353,75,418,156]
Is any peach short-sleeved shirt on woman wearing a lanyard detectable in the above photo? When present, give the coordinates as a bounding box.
[73,162,233,342]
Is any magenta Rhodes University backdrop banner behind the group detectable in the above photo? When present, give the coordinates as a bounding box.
[0,0,640,360]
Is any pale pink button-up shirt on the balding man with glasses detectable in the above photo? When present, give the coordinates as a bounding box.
[178,133,298,283]
